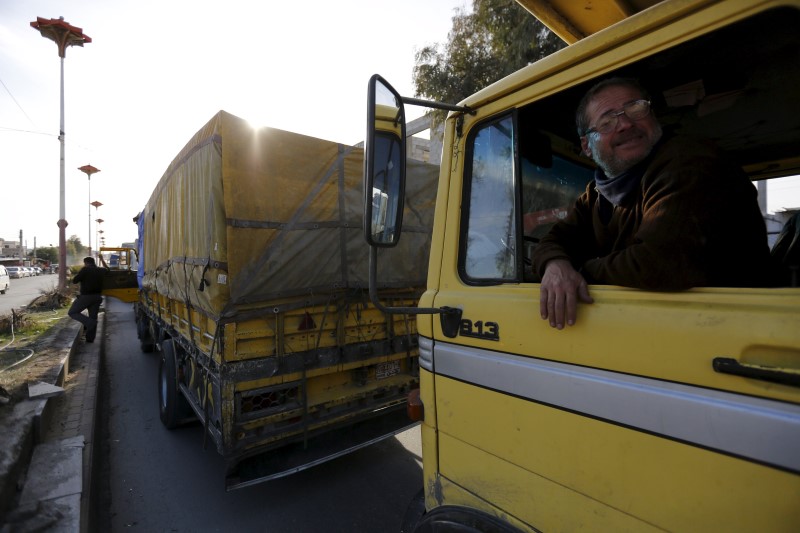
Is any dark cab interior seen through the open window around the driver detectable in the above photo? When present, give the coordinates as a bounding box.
[516,8,800,285]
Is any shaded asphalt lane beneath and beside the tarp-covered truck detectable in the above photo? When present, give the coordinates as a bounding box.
[93,298,422,533]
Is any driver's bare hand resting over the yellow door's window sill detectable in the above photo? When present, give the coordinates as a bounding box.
[539,259,594,329]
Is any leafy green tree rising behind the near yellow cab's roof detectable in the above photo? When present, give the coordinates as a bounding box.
[414,0,565,109]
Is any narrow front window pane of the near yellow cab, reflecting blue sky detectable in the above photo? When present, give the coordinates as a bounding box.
[460,116,517,281]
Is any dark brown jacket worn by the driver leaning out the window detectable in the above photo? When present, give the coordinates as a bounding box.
[533,137,771,290]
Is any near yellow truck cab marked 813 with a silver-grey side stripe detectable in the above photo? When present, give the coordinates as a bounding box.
[365,0,800,532]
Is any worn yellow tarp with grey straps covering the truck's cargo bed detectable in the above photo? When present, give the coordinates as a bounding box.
[140,107,438,319]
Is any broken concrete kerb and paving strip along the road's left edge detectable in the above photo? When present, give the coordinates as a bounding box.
[0,312,106,533]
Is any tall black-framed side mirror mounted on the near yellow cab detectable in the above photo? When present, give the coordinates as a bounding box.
[364,74,406,247]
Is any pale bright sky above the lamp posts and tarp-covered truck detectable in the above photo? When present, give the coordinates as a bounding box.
[0,0,471,254]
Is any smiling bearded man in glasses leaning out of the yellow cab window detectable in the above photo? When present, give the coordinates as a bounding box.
[533,78,772,329]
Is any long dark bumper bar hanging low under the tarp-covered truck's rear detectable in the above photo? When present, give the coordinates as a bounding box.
[225,404,419,491]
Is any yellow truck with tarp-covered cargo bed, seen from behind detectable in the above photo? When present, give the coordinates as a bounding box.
[135,111,438,490]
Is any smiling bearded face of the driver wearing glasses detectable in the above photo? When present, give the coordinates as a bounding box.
[581,85,661,178]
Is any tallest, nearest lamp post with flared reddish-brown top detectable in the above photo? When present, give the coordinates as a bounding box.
[31,17,92,291]
